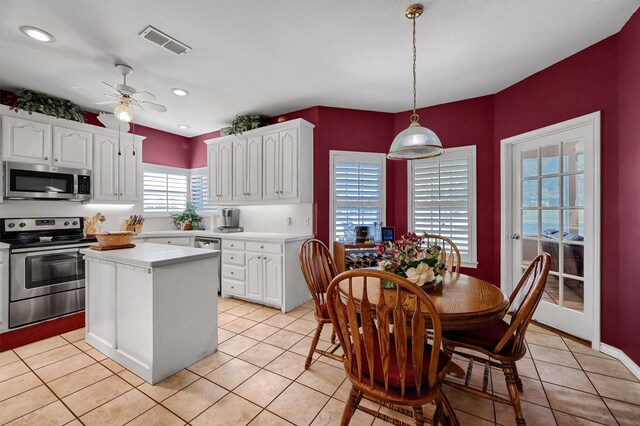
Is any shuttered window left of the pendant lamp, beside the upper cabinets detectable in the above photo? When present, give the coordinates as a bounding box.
[329,151,386,241]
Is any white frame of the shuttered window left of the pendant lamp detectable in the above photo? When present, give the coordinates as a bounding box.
[329,150,387,245]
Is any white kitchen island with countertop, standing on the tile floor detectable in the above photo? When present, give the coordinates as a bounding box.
[81,243,220,384]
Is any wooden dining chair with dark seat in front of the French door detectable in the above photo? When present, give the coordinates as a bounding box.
[443,253,551,425]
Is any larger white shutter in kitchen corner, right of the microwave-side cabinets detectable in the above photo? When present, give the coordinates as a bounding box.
[143,168,189,212]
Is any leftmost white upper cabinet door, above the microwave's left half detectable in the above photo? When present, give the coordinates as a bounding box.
[2,115,51,164]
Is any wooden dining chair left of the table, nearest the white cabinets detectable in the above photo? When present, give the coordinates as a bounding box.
[298,239,342,370]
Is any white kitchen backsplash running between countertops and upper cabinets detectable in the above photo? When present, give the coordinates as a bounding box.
[0,200,313,234]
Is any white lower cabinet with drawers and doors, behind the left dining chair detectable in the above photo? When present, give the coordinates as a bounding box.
[222,239,311,312]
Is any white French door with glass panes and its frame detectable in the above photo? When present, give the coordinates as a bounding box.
[502,113,600,346]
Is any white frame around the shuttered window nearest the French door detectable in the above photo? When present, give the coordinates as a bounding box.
[407,145,478,268]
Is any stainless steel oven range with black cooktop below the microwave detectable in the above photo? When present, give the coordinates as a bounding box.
[0,217,96,328]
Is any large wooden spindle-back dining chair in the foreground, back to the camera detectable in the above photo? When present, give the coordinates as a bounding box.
[327,269,457,426]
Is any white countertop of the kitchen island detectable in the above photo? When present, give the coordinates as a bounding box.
[80,243,220,268]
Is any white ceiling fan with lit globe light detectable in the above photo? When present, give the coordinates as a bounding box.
[79,64,167,123]
